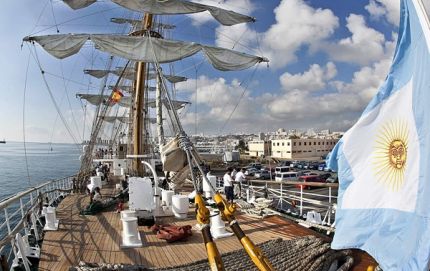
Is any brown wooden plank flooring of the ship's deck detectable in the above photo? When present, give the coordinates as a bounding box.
[39,180,374,270]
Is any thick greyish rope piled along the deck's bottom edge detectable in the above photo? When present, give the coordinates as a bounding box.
[70,236,354,271]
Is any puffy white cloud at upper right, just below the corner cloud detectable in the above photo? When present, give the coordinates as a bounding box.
[322,14,389,65]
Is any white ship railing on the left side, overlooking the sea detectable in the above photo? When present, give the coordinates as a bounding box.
[0,176,75,263]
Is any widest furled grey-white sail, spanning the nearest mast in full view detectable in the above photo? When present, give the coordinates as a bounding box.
[24,34,268,71]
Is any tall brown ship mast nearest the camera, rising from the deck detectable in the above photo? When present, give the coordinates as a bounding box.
[133,13,153,176]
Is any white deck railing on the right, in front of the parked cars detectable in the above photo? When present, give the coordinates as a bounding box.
[217,180,339,231]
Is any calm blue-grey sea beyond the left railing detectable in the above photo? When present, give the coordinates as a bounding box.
[0,142,81,201]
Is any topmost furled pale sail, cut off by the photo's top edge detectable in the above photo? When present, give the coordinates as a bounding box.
[63,0,255,25]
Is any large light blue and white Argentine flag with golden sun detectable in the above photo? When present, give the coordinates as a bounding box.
[329,0,430,271]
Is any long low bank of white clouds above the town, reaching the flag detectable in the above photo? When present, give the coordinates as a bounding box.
[177,56,390,134]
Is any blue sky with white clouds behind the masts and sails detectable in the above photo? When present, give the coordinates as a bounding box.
[0,0,400,142]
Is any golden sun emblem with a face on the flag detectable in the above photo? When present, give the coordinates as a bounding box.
[372,119,409,191]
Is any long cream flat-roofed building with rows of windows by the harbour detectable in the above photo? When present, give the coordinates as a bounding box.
[271,138,339,159]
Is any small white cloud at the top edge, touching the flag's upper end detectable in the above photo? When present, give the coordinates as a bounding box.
[365,0,400,25]
